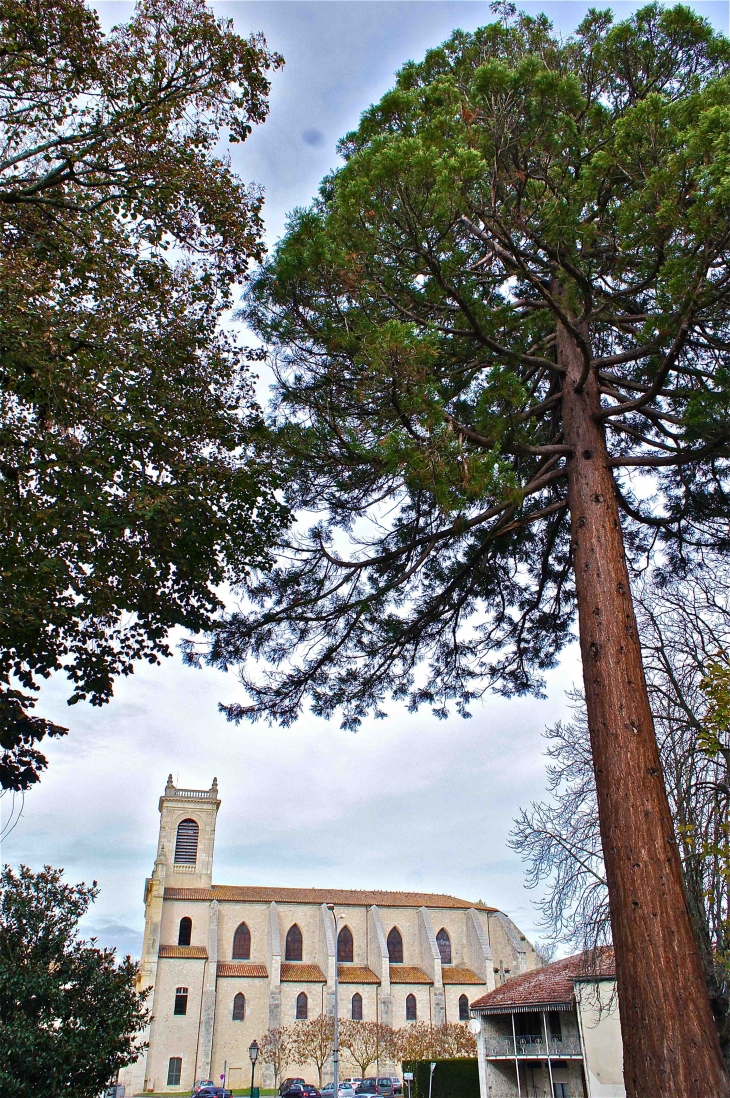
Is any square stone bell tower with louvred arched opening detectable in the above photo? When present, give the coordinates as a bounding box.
[157,774,221,888]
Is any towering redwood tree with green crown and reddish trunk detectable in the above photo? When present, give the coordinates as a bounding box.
[190,5,730,1098]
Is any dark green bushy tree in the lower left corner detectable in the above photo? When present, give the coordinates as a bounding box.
[0,865,148,1098]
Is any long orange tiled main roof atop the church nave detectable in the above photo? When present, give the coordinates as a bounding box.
[165,885,497,911]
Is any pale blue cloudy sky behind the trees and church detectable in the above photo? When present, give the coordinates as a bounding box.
[0,0,728,955]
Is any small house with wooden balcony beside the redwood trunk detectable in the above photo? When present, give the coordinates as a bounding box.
[471,950,626,1098]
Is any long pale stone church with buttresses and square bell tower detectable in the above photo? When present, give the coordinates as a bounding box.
[120,775,541,1096]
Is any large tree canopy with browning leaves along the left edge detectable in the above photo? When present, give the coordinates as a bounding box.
[0,0,281,789]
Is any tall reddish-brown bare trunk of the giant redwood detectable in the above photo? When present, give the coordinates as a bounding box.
[558,316,728,1098]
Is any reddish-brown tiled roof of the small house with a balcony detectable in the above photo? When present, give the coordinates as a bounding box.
[471,949,616,1015]
